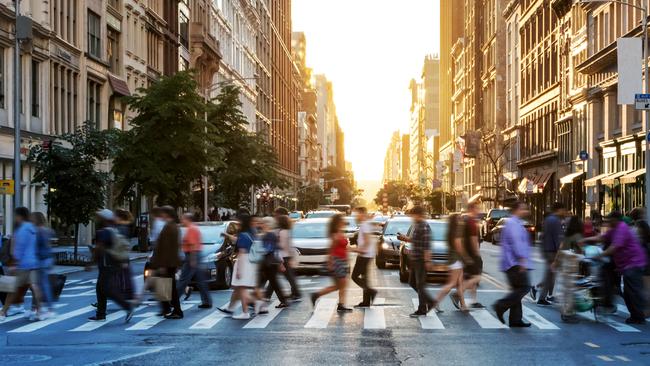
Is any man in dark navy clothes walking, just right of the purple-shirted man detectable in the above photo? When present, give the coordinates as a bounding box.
[530,202,566,306]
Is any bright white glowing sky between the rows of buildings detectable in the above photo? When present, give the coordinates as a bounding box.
[292,0,440,199]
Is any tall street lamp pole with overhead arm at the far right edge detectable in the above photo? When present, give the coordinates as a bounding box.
[580,0,650,221]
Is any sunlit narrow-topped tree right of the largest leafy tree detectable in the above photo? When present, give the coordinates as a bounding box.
[208,84,287,208]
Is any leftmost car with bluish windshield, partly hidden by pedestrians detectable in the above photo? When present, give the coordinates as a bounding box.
[144,221,237,289]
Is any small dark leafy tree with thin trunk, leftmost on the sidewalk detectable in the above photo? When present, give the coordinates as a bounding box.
[27,122,119,259]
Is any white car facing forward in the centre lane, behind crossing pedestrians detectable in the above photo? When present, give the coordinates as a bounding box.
[291,218,331,271]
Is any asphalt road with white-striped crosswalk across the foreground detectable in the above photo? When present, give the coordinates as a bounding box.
[0,244,650,366]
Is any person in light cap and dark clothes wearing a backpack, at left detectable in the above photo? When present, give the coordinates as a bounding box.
[88,209,133,323]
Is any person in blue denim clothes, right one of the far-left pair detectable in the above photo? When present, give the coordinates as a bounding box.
[31,212,56,319]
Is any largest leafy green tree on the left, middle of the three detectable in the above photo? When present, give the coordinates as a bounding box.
[113,71,213,207]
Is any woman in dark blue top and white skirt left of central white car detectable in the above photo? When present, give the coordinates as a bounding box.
[219,209,257,320]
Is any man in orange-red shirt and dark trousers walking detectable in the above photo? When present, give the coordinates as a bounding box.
[178,212,212,309]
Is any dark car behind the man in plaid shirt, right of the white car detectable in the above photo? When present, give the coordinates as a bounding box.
[399,220,449,283]
